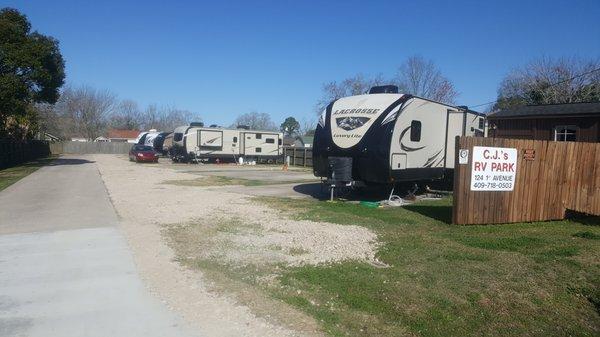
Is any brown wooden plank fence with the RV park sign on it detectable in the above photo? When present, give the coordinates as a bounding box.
[452,137,600,224]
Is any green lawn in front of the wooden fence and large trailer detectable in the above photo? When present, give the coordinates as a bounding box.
[260,198,600,336]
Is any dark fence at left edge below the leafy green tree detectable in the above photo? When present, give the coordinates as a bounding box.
[0,139,50,169]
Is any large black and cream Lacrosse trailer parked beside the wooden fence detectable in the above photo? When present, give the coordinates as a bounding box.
[313,86,484,185]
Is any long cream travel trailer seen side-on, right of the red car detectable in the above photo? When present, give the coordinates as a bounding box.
[171,123,283,162]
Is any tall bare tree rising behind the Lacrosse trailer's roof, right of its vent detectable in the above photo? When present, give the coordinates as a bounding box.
[394,56,458,104]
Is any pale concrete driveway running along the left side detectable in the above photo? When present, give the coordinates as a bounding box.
[0,156,196,337]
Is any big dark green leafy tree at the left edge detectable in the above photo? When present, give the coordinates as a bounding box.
[0,8,65,138]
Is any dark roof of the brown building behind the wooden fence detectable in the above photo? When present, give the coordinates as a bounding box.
[488,102,600,119]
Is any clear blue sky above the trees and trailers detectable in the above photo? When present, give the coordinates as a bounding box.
[0,0,600,125]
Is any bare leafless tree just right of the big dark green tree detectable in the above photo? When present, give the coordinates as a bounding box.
[56,86,116,140]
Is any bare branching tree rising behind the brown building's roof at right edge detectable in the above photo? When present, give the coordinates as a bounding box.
[492,57,600,111]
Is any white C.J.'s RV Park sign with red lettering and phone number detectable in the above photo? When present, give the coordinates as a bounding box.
[471,146,518,191]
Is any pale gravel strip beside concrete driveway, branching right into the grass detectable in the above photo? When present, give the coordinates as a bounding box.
[95,155,377,336]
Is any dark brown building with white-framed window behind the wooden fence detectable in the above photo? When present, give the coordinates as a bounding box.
[487,102,600,143]
